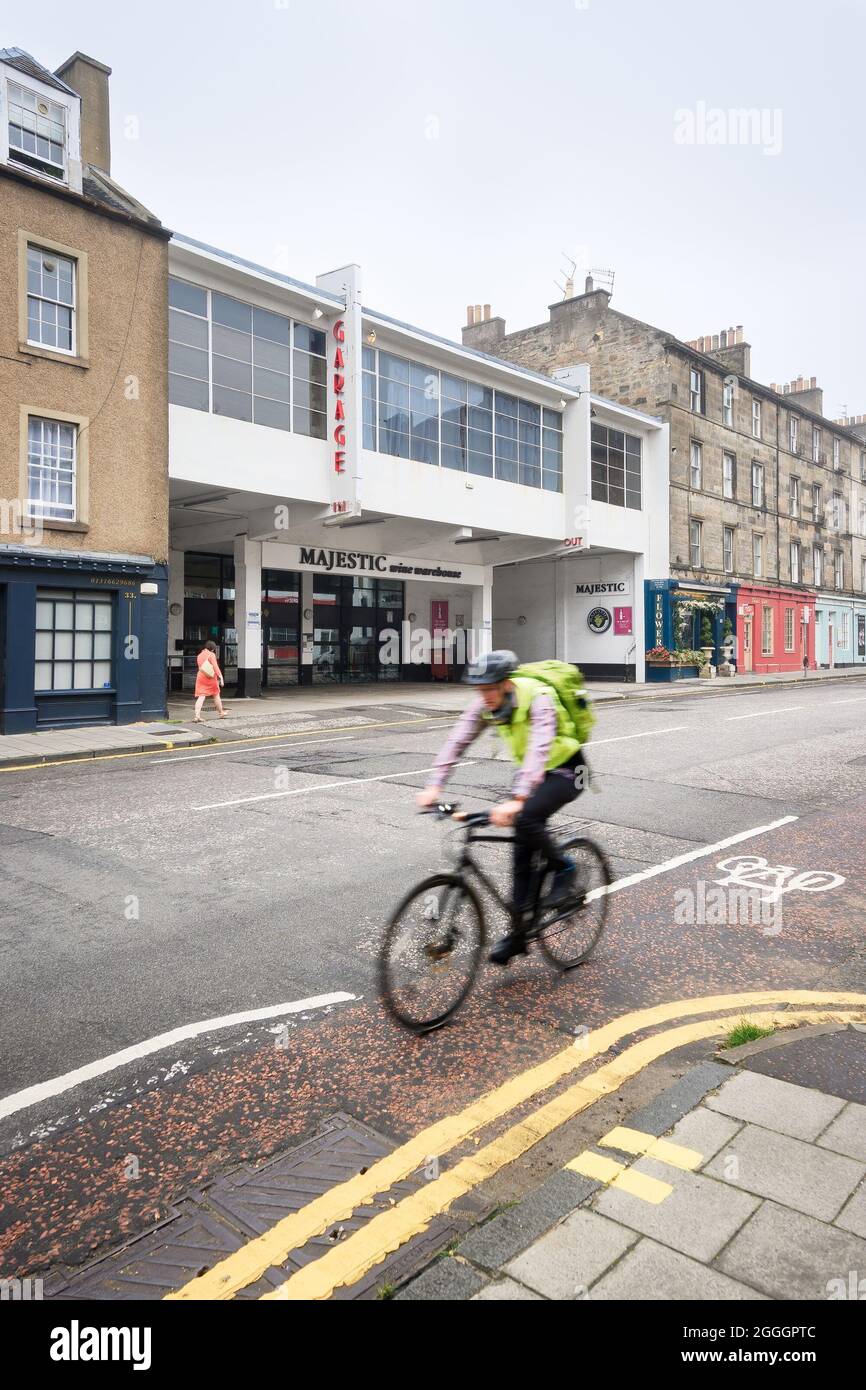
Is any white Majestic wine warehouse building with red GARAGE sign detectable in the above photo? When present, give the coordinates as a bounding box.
[170,244,669,695]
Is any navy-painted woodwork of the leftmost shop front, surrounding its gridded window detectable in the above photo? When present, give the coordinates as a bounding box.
[0,546,168,734]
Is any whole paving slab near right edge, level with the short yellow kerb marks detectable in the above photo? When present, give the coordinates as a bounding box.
[705,1125,866,1220]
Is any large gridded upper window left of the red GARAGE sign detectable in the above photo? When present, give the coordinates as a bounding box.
[168,278,325,439]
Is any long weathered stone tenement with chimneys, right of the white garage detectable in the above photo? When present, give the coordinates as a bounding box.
[463,278,866,670]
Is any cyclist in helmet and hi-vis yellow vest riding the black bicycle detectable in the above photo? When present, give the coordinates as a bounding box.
[416,651,584,965]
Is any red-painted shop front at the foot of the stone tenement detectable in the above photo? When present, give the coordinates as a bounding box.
[737,584,815,674]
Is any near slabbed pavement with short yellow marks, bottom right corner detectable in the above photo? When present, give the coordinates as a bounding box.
[392,1024,866,1302]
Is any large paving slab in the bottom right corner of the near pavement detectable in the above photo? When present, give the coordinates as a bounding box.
[714,1202,866,1301]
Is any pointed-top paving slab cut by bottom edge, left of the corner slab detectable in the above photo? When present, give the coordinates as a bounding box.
[589,1240,766,1302]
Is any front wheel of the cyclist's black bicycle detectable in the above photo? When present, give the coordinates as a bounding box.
[379,874,485,1033]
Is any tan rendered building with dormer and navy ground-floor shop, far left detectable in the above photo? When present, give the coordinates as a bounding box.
[0,49,170,734]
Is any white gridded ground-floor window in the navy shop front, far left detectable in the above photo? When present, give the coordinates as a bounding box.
[35,589,114,691]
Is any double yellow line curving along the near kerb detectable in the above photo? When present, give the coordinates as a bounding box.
[167,990,866,1301]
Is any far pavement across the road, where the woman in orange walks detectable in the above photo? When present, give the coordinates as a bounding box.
[0,666,866,769]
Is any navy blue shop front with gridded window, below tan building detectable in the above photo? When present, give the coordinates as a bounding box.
[0,545,168,734]
